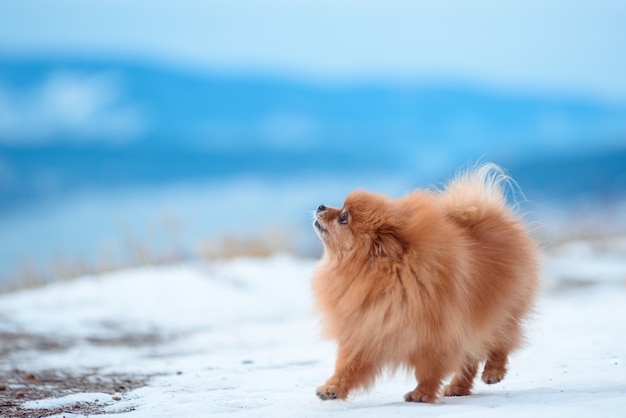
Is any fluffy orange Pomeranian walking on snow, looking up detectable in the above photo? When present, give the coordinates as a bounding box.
[313,164,538,402]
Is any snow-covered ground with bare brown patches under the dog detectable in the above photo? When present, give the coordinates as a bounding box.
[0,239,626,418]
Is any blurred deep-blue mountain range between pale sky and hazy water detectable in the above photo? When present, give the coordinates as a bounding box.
[0,57,626,209]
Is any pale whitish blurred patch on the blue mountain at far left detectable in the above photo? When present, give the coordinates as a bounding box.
[0,72,146,144]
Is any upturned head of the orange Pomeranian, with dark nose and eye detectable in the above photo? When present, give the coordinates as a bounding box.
[314,191,405,257]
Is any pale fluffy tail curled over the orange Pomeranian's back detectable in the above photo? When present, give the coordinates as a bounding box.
[438,163,517,224]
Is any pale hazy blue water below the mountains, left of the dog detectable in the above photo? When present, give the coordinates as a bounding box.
[0,176,416,280]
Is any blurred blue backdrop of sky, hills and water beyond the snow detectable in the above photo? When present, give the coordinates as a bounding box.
[0,0,626,288]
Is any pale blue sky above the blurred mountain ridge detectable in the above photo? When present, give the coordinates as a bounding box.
[0,0,626,102]
